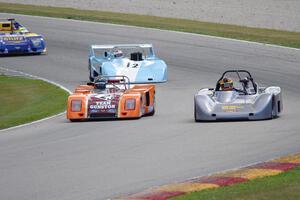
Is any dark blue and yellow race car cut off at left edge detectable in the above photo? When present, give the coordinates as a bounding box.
[0,19,47,55]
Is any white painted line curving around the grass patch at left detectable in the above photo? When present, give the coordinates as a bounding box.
[0,67,72,132]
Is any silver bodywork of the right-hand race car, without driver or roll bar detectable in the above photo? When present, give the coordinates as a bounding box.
[194,70,283,121]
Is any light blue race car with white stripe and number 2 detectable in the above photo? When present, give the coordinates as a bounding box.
[88,44,167,83]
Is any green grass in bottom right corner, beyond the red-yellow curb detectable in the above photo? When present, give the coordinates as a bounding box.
[172,168,300,200]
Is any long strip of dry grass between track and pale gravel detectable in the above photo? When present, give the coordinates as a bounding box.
[0,3,300,48]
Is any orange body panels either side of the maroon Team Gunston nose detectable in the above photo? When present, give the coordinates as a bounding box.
[67,85,155,121]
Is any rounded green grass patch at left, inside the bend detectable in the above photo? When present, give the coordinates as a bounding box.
[0,75,68,129]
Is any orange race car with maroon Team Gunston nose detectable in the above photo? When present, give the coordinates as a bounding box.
[67,76,155,121]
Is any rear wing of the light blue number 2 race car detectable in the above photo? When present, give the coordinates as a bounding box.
[90,44,155,58]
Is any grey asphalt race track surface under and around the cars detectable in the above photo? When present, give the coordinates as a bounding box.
[0,14,300,200]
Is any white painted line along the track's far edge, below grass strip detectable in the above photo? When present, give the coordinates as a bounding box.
[0,13,300,51]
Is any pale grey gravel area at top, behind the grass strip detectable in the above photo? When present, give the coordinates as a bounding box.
[0,0,300,32]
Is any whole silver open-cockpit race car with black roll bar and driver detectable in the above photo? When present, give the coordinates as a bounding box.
[194,70,283,122]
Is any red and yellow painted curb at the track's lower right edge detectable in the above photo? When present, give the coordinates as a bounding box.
[111,153,300,200]
